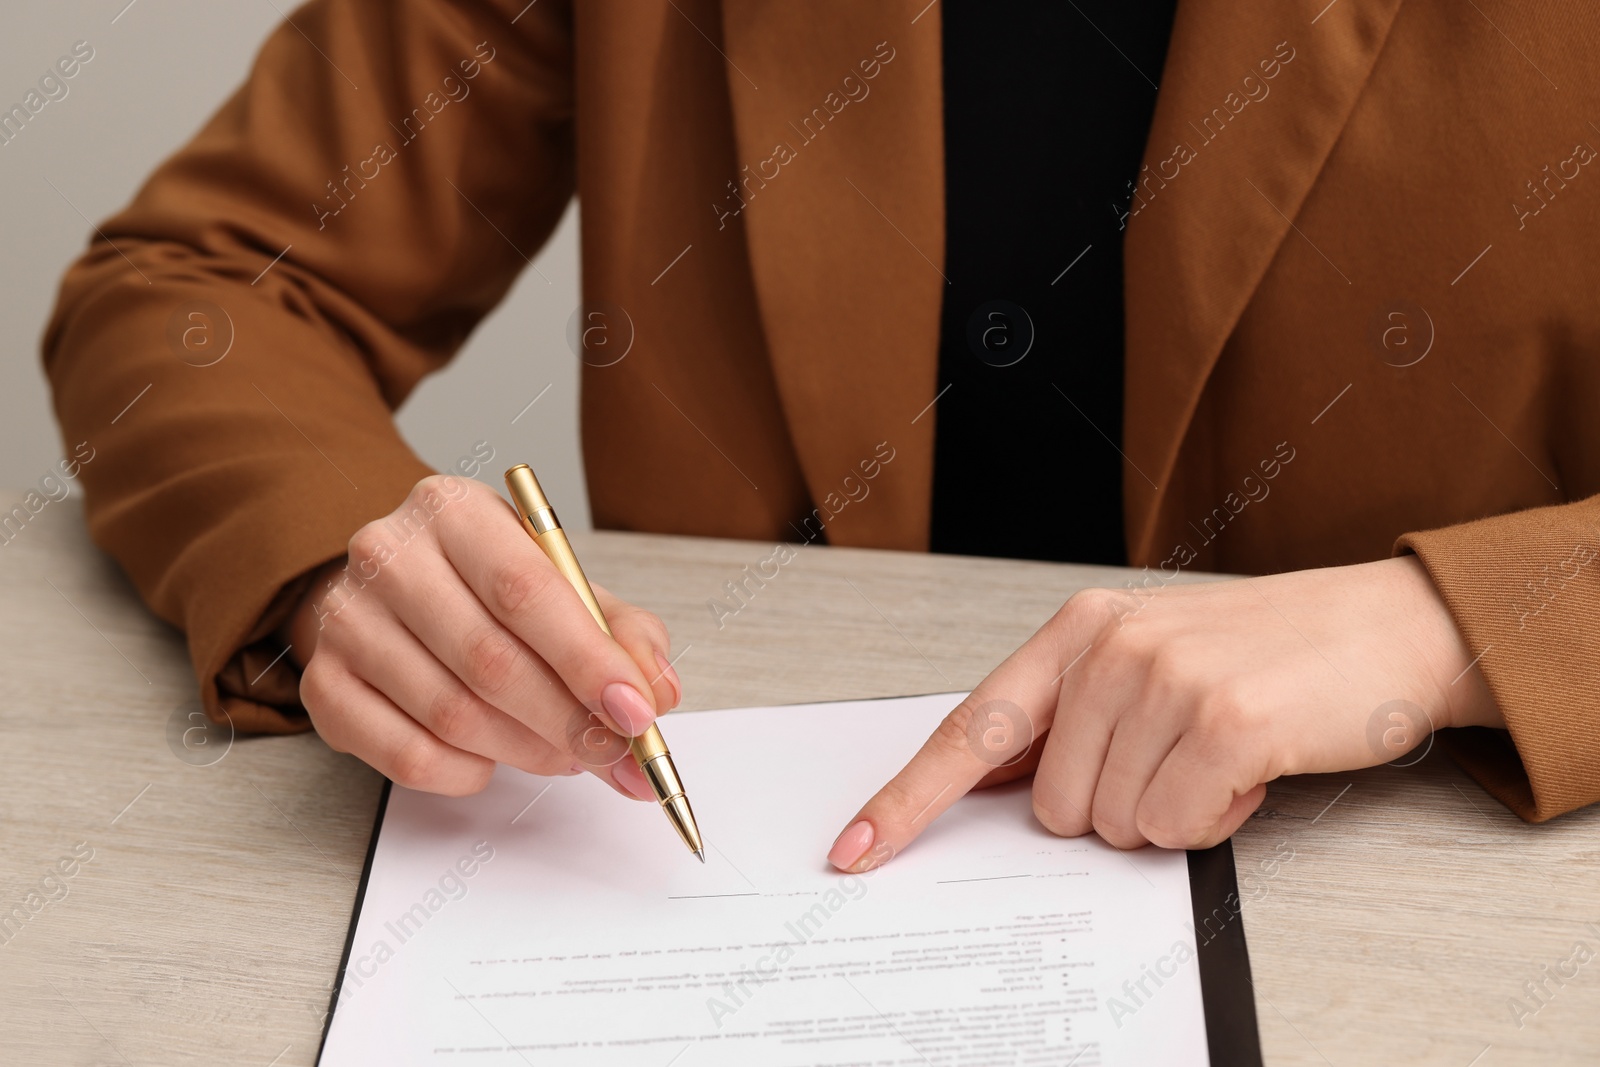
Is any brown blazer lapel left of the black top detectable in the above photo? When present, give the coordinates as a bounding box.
[714,0,946,549]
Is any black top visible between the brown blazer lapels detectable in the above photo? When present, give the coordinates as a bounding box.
[931,0,1176,563]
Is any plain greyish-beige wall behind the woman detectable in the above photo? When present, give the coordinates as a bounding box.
[0,0,589,526]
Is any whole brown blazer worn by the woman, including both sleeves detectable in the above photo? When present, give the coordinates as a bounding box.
[45,0,1600,819]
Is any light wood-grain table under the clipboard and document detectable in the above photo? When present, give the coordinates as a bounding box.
[0,502,1600,1067]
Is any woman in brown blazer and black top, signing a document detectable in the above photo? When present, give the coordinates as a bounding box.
[45,0,1600,869]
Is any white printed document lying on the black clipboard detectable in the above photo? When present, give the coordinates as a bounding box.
[320,694,1206,1067]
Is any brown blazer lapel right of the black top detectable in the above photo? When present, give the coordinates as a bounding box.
[1123,0,1400,560]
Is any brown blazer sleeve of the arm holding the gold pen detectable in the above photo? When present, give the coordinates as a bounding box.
[43,0,574,733]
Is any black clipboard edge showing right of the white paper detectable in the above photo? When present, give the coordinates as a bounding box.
[1189,840,1261,1067]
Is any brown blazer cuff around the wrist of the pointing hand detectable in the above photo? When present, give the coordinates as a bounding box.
[1395,496,1600,822]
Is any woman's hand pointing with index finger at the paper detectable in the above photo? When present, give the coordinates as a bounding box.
[829,557,1504,870]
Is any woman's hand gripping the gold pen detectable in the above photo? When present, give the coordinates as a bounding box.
[283,475,682,800]
